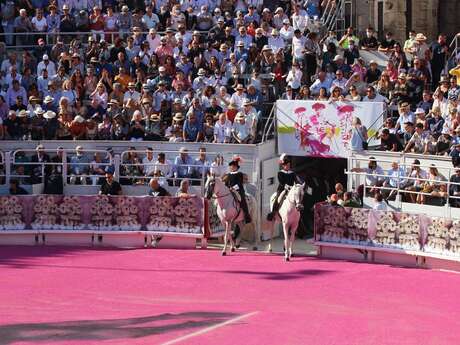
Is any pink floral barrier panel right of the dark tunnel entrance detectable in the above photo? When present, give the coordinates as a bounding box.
[314,203,460,256]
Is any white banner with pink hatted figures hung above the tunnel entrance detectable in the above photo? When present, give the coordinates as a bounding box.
[276,100,384,158]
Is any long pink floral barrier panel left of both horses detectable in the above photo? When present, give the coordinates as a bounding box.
[0,195,207,235]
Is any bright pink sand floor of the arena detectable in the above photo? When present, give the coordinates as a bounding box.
[0,247,460,345]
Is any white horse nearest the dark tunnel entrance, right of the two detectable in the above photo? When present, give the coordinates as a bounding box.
[268,183,305,261]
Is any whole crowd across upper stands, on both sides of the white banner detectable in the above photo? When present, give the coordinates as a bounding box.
[0,0,460,148]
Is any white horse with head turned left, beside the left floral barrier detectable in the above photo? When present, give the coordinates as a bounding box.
[205,175,253,255]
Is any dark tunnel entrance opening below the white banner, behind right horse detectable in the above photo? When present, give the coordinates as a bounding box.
[292,157,347,238]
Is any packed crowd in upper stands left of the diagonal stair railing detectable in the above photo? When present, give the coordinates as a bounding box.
[0,0,328,143]
